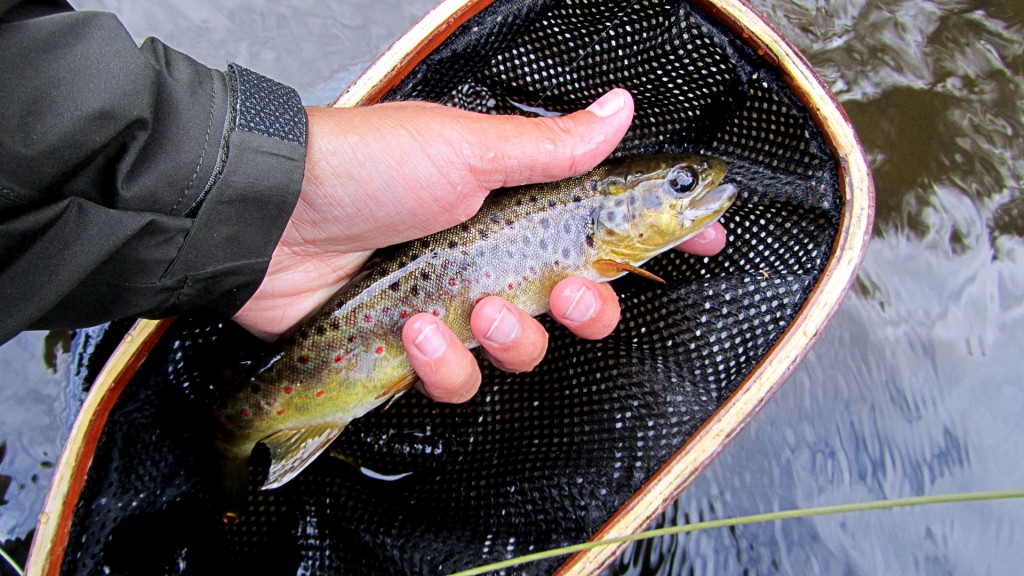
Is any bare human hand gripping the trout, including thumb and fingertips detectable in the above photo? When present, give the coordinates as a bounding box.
[234,90,725,402]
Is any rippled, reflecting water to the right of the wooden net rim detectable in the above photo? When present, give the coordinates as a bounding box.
[610,0,1024,574]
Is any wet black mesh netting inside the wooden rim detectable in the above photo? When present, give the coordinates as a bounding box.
[62,0,841,576]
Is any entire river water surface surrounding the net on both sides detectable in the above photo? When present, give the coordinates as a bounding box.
[0,0,1024,576]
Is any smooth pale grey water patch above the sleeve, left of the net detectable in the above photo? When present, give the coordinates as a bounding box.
[64,0,436,105]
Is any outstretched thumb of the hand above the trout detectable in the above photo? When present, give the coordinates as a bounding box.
[462,88,633,190]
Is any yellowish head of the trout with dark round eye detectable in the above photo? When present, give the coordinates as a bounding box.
[594,155,736,263]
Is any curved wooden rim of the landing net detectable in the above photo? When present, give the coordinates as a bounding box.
[27,0,874,575]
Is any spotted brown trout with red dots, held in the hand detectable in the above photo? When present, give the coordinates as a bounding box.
[211,155,736,504]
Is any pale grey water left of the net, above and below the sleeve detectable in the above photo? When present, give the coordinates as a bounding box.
[0,0,435,561]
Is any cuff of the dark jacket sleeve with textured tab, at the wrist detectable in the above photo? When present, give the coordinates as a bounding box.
[163,65,307,317]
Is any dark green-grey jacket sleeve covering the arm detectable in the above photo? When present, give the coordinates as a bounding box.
[0,0,306,343]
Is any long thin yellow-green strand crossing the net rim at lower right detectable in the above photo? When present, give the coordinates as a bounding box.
[452,490,1024,576]
